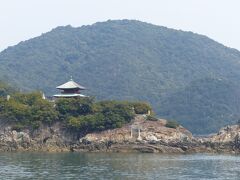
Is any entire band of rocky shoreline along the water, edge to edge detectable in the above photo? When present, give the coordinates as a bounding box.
[0,115,240,154]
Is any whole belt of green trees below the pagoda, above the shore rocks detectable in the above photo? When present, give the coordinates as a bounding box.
[0,92,151,134]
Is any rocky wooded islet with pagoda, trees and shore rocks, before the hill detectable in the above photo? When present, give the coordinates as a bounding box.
[0,79,240,153]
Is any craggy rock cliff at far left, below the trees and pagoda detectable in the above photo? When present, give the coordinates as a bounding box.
[0,123,74,152]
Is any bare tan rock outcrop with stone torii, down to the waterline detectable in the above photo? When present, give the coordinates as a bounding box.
[76,116,193,153]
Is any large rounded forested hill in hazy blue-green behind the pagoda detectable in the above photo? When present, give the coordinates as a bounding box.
[0,20,240,133]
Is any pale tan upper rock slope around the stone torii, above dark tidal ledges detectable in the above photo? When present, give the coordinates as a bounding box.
[80,116,192,143]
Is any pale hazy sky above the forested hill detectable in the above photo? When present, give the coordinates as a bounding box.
[0,0,240,51]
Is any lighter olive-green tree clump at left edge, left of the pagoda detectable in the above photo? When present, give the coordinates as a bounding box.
[0,92,58,129]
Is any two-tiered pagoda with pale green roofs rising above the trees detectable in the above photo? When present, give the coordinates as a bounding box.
[53,78,87,98]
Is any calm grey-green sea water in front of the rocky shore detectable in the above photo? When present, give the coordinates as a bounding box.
[0,153,240,180]
